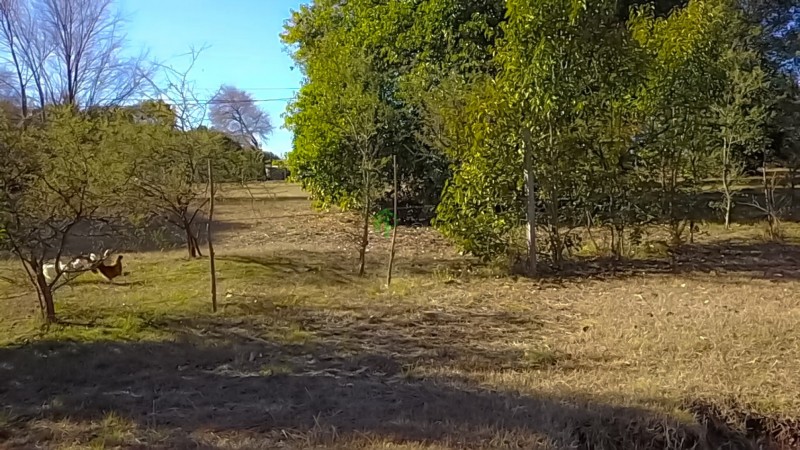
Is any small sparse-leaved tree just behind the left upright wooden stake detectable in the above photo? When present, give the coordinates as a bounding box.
[101,101,244,258]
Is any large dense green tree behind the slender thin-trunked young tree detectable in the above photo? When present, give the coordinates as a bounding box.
[283,0,504,218]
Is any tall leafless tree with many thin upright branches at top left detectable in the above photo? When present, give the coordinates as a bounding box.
[0,0,152,117]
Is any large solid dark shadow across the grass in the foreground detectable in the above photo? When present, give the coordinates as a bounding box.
[0,341,755,449]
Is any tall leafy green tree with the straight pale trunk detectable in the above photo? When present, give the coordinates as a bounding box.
[497,0,627,275]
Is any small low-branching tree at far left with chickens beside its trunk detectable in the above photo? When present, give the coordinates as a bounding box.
[0,107,126,323]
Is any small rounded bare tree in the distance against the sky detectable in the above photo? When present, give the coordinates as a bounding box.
[210,85,273,149]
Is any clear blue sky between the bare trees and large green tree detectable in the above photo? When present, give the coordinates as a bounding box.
[121,0,310,155]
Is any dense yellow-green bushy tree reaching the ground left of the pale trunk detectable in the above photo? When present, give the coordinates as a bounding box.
[434,75,525,259]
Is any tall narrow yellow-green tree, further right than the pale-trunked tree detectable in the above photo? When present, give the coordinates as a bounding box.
[631,1,729,246]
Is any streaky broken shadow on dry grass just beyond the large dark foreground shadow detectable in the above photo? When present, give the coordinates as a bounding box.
[139,306,588,373]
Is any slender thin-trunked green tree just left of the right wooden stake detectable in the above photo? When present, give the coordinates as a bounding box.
[287,27,397,275]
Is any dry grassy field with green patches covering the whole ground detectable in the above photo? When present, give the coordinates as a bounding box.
[0,183,800,450]
